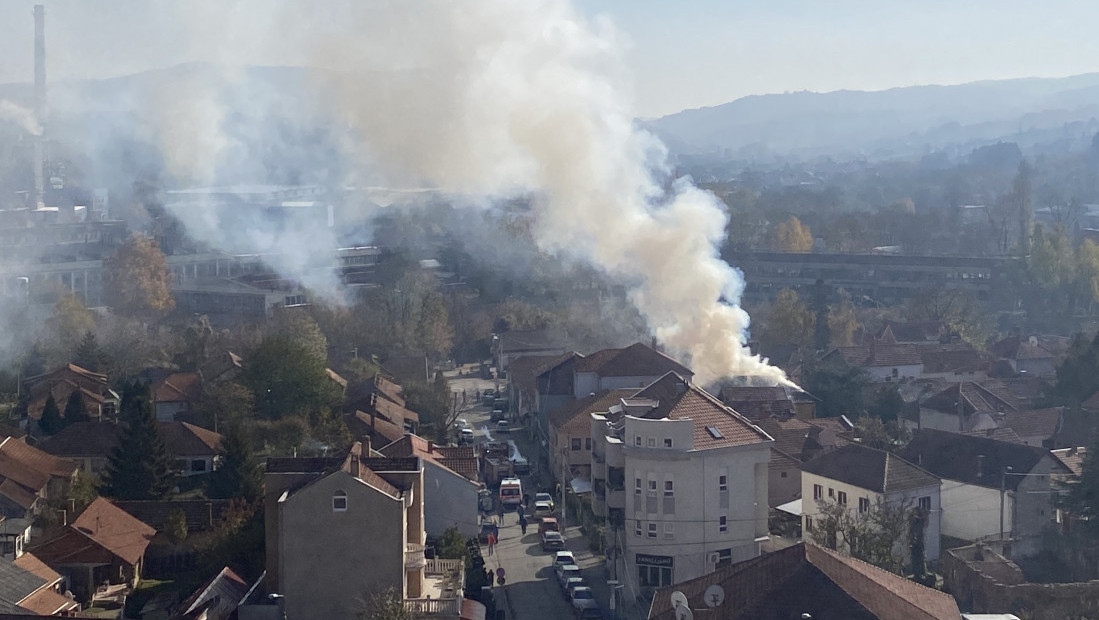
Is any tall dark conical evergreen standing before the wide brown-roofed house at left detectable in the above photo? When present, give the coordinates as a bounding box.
[100,384,175,499]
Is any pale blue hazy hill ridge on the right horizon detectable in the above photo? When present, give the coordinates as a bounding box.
[642,74,1099,159]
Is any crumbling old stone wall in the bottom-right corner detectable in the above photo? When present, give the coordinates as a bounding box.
[942,545,1099,620]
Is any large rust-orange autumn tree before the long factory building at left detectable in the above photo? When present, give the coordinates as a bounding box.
[103,233,176,321]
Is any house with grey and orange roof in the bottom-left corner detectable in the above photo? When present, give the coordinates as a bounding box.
[0,553,80,618]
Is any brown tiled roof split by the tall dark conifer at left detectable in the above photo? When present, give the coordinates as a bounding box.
[38,421,221,457]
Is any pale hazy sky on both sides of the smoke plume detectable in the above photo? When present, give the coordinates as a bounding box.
[0,0,1099,117]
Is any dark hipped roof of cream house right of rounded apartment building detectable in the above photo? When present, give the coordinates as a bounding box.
[801,443,940,494]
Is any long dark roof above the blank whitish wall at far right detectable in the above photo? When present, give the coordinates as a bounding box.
[900,429,1068,490]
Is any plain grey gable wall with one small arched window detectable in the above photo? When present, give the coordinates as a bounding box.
[279,472,407,620]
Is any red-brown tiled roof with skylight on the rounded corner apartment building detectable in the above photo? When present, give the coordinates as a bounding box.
[634,373,773,450]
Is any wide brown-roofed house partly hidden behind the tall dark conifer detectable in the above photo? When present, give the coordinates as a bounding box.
[38,421,221,476]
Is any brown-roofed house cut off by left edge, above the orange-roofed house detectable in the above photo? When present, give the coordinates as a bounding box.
[0,438,77,532]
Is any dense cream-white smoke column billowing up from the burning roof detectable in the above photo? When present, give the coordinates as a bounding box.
[307,0,787,383]
